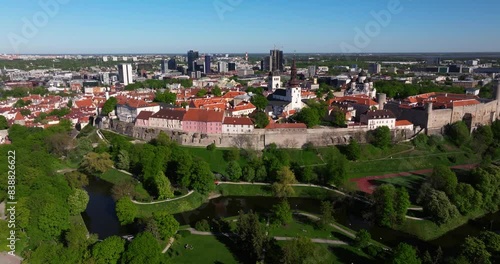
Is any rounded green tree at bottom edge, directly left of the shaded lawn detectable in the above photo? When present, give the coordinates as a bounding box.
[121,232,162,264]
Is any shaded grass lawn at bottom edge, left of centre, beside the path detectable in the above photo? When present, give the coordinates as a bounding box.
[167,235,238,264]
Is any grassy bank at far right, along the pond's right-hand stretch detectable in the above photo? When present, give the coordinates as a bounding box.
[395,210,486,241]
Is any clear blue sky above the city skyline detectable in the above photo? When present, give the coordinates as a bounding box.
[0,0,500,54]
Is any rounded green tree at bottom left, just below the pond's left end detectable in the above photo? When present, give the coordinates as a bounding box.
[92,236,125,264]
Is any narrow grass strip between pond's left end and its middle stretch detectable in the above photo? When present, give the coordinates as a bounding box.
[136,192,206,218]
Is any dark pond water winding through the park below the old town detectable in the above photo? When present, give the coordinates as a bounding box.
[84,179,500,254]
